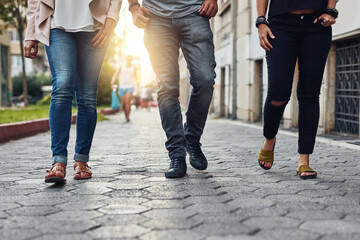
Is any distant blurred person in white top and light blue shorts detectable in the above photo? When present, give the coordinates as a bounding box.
[111,55,136,122]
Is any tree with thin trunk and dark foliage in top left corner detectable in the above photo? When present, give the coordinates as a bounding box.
[0,0,29,106]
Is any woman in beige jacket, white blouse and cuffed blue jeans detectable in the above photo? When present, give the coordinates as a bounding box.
[24,0,121,183]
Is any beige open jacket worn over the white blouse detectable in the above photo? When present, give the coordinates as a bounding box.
[25,0,122,45]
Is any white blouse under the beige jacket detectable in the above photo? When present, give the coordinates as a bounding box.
[51,0,96,32]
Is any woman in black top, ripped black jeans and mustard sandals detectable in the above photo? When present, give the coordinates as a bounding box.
[256,0,338,179]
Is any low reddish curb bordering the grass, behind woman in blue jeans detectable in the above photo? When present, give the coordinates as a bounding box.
[0,114,76,143]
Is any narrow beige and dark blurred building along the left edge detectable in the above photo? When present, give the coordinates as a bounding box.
[0,32,12,107]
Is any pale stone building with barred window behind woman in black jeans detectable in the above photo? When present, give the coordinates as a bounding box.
[179,0,360,137]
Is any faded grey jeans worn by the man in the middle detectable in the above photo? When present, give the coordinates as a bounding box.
[145,13,216,158]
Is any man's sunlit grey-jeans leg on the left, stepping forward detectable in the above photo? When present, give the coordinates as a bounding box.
[145,17,186,159]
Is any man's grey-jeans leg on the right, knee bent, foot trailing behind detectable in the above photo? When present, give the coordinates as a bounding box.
[180,14,216,143]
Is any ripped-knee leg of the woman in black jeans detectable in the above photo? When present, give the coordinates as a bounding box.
[259,28,298,169]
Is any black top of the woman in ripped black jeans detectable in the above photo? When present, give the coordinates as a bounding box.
[268,0,329,18]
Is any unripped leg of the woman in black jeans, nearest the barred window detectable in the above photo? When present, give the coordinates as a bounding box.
[297,26,331,176]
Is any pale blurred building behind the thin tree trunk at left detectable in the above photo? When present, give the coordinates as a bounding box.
[8,28,50,77]
